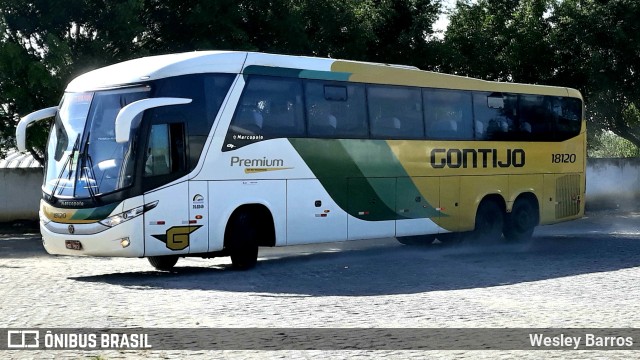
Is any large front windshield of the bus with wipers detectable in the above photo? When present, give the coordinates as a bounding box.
[43,87,149,198]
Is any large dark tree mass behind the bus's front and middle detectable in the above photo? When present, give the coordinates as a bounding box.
[0,0,441,159]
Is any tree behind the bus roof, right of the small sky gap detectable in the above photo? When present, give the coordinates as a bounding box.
[443,0,553,83]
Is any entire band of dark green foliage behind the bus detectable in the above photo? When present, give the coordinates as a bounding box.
[0,0,640,160]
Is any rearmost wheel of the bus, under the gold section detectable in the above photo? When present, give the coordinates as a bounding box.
[504,198,538,242]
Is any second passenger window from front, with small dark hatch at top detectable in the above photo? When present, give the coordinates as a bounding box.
[305,80,369,139]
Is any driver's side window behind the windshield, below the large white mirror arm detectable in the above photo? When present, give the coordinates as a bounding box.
[144,123,186,177]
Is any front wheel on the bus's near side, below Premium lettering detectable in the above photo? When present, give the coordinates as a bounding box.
[227,211,258,270]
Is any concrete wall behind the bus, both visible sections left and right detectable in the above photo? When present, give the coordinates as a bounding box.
[0,158,640,222]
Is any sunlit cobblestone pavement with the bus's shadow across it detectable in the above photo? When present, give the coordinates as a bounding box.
[0,212,640,359]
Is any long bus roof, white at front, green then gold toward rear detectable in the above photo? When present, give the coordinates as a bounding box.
[67,51,582,98]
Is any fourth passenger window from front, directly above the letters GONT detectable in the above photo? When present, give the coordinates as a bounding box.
[423,89,479,140]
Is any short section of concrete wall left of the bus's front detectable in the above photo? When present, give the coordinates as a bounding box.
[0,168,43,222]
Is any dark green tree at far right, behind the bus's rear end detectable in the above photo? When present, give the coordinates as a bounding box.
[553,0,640,147]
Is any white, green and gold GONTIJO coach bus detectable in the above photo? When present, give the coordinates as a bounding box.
[16,51,586,270]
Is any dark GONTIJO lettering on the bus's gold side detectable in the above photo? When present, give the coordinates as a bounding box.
[431,148,525,169]
